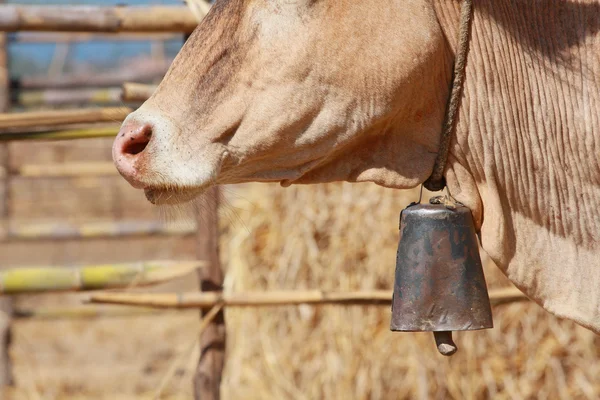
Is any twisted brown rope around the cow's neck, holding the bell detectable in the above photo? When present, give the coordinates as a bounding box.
[424,0,473,192]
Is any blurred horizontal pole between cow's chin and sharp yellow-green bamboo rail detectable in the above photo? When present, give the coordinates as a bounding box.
[4,221,196,240]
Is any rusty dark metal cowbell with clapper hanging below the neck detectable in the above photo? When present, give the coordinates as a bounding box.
[391,197,493,356]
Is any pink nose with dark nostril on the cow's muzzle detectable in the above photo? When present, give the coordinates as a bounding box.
[113,122,152,189]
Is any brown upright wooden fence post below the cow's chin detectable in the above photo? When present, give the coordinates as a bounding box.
[194,187,226,400]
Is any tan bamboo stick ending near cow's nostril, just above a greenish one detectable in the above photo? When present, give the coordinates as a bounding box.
[0,107,133,133]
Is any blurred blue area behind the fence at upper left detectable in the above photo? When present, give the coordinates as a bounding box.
[6,0,182,78]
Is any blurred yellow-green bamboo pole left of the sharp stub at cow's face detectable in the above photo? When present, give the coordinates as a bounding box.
[12,88,121,108]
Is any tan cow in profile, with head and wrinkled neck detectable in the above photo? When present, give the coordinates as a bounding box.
[113,0,600,333]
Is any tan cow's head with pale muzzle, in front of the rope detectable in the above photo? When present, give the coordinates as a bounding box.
[113,0,452,204]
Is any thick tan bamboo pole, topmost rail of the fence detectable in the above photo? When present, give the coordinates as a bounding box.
[0,5,198,33]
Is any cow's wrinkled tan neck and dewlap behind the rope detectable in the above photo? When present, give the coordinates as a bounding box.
[436,0,600,332]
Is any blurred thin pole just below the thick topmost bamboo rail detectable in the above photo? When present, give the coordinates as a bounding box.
[9,32,181,43]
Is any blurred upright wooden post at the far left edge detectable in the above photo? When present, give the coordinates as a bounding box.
[0,4,13,390]
